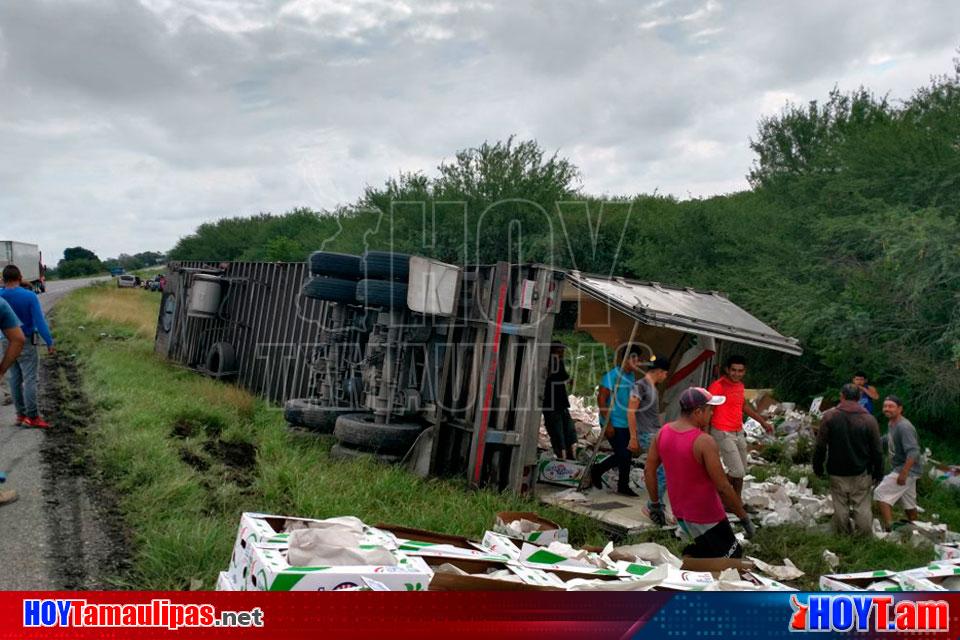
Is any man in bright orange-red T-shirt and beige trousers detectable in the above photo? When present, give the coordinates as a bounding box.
[707,356,773,497]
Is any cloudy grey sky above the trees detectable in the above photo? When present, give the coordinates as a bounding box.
[0,0,960,263]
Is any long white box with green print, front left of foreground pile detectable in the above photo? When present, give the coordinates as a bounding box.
[246,547,433,591]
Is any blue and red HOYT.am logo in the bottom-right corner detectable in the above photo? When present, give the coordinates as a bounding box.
[789,594,950,633]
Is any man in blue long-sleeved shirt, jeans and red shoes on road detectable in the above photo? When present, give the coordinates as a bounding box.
[0,264,54,429]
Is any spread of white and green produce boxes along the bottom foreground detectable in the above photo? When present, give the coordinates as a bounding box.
[217,512,960,591]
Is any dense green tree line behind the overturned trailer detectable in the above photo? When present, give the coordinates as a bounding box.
[169,61,960,430]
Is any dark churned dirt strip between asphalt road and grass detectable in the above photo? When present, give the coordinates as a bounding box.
[40,352,131,589]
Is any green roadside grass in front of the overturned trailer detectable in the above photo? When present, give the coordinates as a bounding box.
[55,285,960,589]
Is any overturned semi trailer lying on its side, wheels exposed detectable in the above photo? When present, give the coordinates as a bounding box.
[156,252,800,492]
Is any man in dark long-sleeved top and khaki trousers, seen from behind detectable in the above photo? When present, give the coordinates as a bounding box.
[813,384,883,535]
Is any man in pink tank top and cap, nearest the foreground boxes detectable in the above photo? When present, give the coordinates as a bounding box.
[644,387,754,558]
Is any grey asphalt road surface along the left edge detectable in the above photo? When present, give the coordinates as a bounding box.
[0,278,104,590]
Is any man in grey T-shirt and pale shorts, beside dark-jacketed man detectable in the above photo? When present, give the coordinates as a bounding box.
[873,396,923,531]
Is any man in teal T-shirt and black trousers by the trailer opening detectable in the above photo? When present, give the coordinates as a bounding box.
[590,345,641,496]
